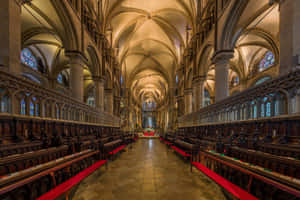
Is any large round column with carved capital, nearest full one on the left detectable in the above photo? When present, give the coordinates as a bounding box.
[66,52,85,101]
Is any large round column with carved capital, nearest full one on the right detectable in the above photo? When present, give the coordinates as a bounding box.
[212,50,234,102]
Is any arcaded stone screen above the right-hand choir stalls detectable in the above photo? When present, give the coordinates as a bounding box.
[178,70,300,127]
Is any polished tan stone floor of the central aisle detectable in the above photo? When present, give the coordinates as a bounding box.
[72,139,226,200]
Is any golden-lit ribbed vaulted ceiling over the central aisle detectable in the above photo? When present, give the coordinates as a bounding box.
[102,0,196,108]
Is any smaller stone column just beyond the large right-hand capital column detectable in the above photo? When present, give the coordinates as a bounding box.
[193,76,206,112]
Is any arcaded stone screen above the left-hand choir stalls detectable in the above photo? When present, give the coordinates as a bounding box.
[0,70,119,126]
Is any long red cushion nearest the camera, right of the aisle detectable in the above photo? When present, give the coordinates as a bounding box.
[192,162,258,200]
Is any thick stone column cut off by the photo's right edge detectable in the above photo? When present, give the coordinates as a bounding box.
[279,0,300,74]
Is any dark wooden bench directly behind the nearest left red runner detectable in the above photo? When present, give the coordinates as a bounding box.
[0,150,100,199]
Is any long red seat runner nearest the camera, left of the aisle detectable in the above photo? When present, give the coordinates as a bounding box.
[37,160,107,200]
